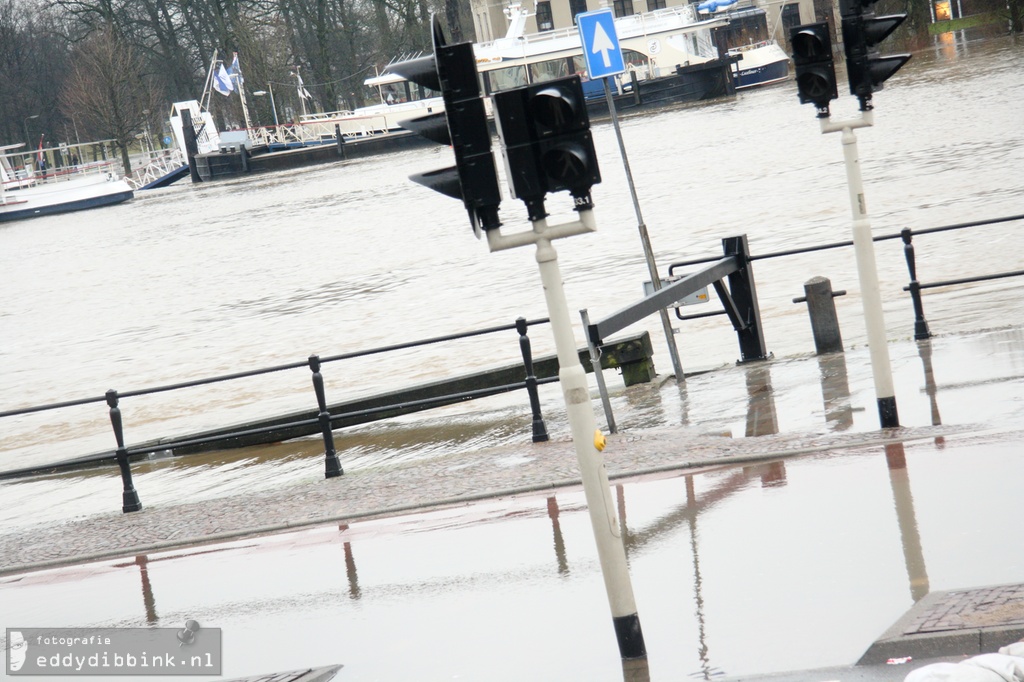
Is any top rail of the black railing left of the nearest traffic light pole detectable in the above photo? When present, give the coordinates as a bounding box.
[0,317,550,419]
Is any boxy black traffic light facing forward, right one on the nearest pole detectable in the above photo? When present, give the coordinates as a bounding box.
[493,76,601,219]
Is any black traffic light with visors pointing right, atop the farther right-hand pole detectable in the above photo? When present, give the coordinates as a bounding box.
[840,0,910,111]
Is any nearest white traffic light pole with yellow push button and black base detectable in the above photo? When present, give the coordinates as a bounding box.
[486,209,647,658]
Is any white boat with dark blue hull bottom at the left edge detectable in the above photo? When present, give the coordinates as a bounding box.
[0,143,133,222]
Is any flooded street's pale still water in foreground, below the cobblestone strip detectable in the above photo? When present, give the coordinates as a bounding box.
[0,437,1024,681]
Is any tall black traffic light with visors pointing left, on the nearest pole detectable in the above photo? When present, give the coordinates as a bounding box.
[388,14,502,230]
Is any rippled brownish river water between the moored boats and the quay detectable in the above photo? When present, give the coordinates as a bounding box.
[0,38,1024,469]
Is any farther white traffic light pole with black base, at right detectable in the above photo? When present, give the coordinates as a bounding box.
[818,110,899,428]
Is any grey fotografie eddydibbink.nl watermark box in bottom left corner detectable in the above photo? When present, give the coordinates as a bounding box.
[6,621,221,676]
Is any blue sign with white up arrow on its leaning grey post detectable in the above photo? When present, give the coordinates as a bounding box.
[577,9,685,382]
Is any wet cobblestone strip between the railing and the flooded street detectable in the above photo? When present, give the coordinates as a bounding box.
[0,419,983,574]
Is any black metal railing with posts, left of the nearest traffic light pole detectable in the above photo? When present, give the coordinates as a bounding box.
[0,317,558,512]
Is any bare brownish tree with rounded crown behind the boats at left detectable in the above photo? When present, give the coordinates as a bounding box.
[60,32,158,173]
